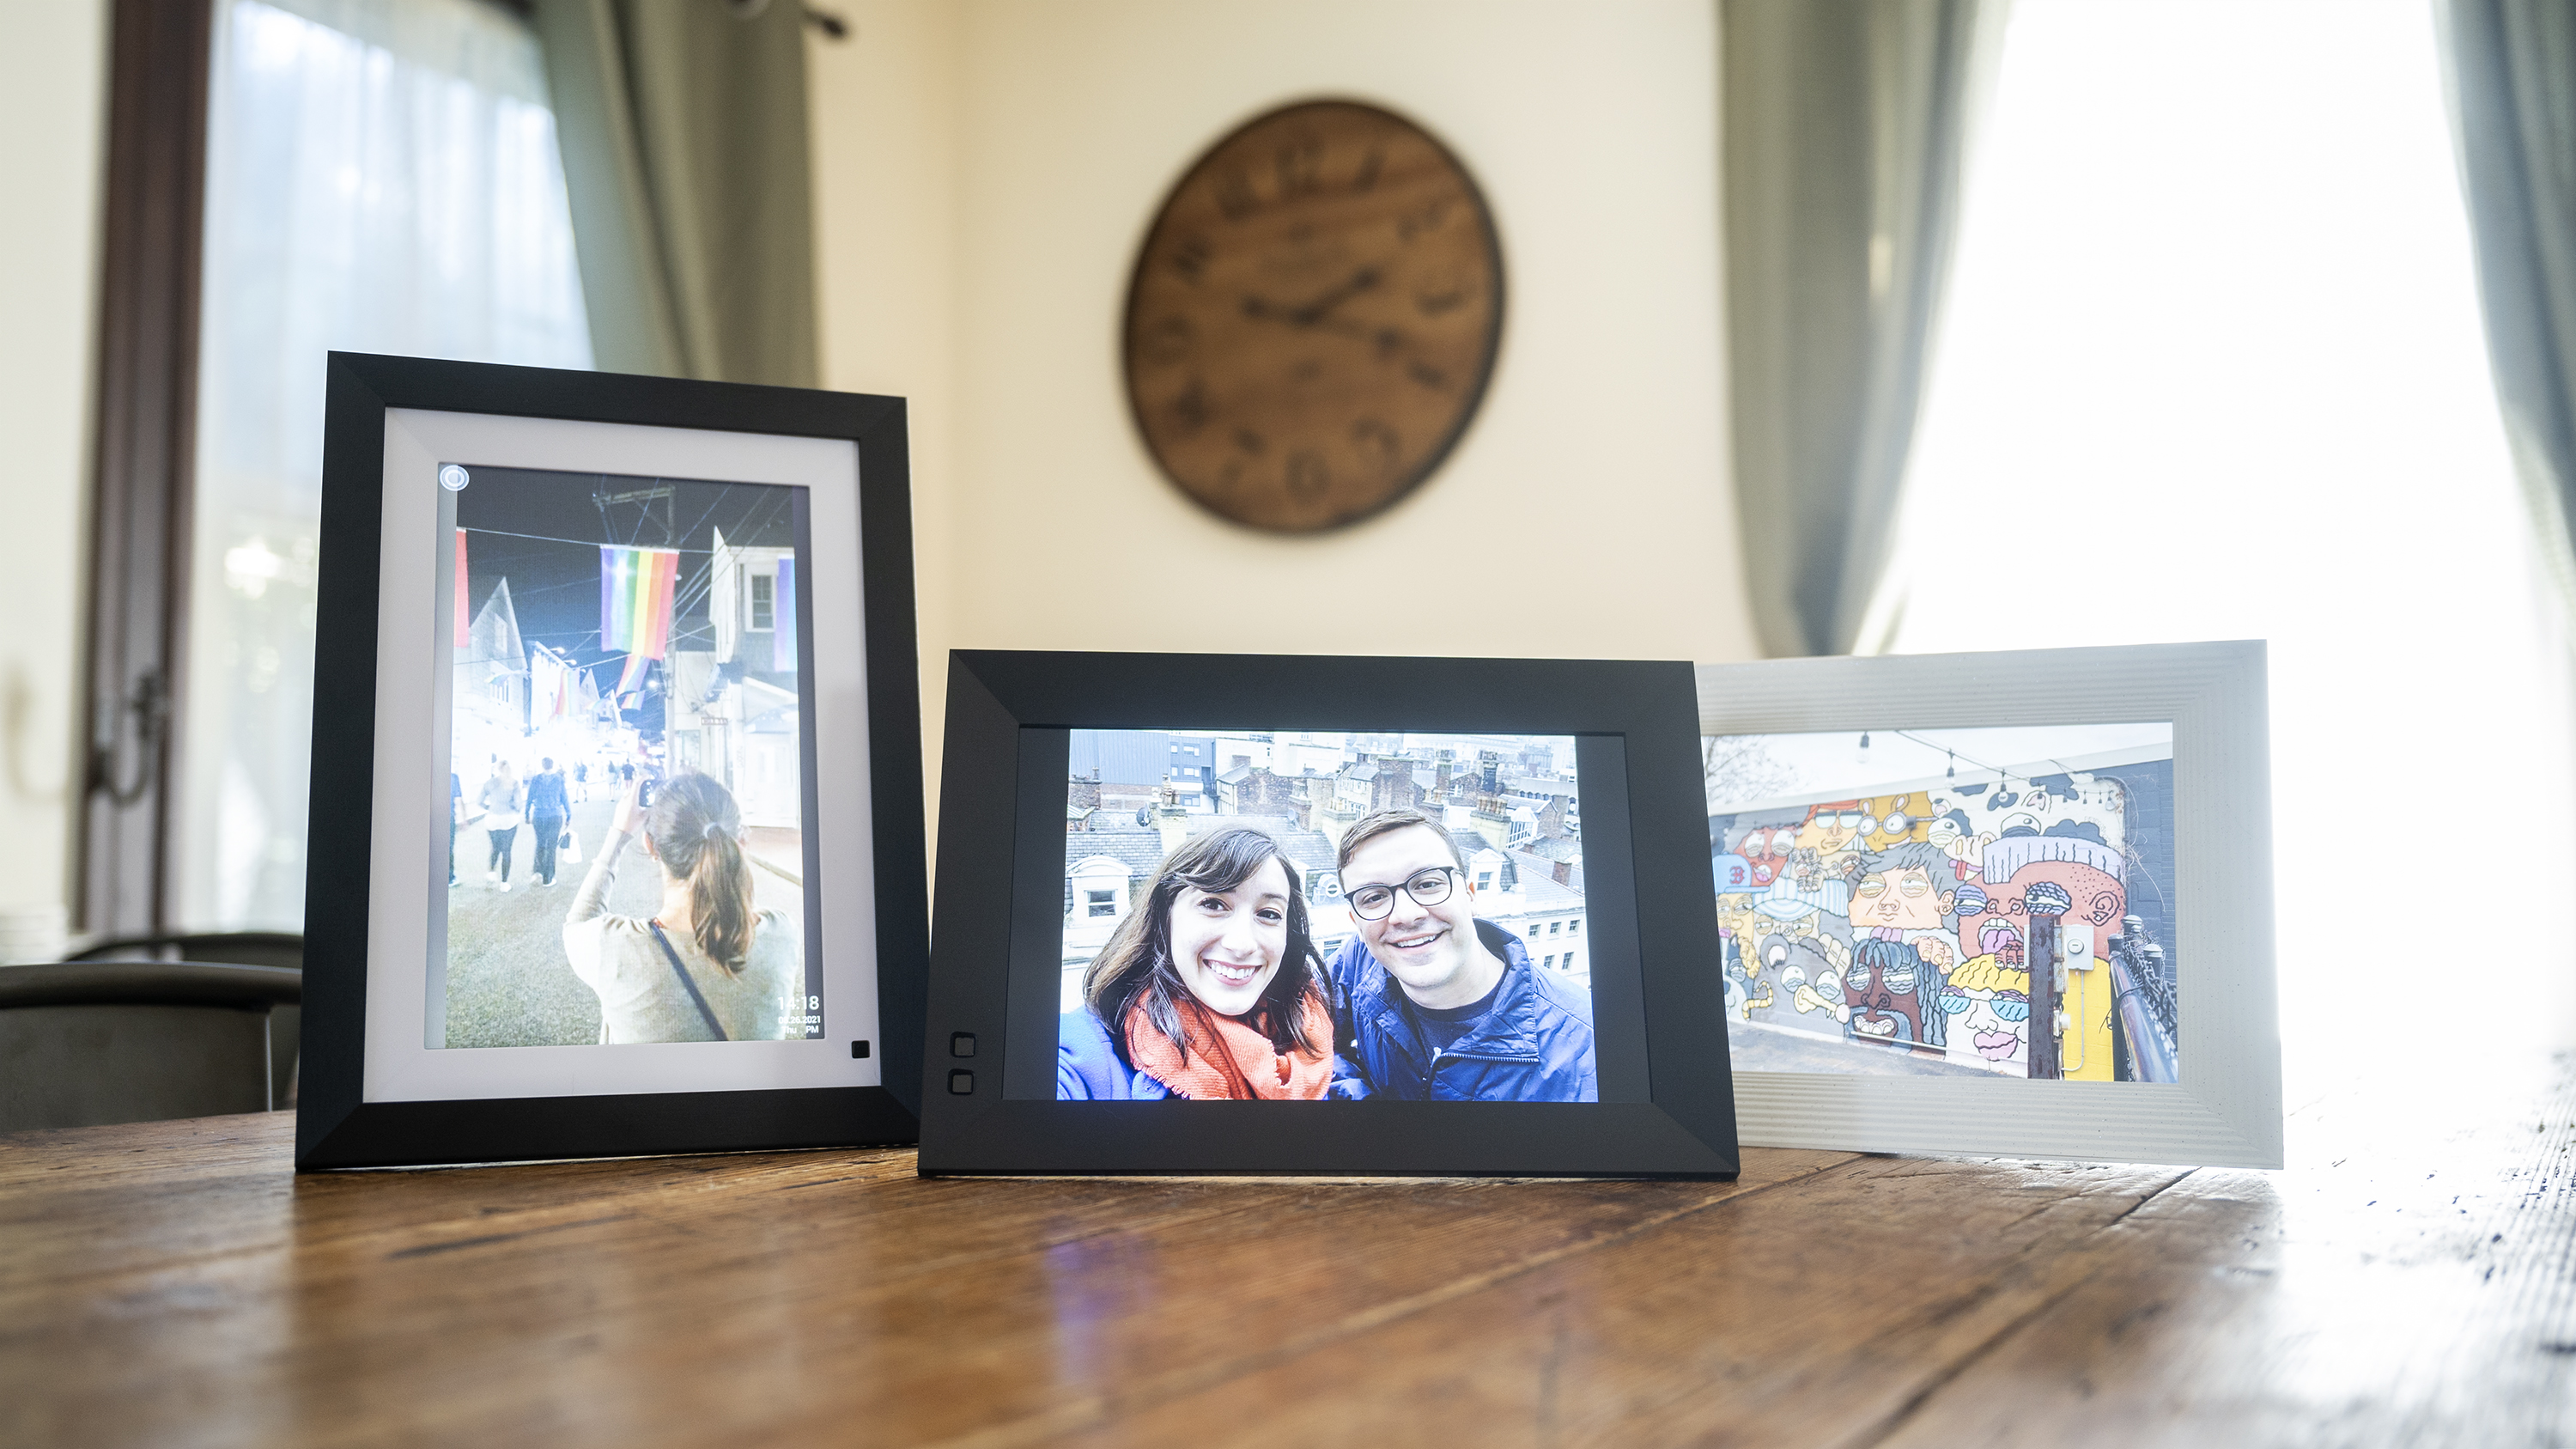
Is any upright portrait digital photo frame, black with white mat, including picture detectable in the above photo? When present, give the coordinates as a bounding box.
[296,353,927,1168]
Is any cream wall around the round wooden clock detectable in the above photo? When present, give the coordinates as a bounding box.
[814,0,1754,819]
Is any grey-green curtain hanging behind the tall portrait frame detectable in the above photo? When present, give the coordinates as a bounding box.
[536,0,814,387]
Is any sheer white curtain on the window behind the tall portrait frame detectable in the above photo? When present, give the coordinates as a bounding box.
[180,0,590,931]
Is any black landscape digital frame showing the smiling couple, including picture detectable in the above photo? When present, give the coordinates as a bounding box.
[920,649,1736,1178]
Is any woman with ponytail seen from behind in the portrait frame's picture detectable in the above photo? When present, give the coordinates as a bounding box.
[564,774,806,1044]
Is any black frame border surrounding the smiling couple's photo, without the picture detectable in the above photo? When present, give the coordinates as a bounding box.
[920,649,1739,1178]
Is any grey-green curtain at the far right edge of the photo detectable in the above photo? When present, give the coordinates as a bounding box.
[2439,0,2576,608]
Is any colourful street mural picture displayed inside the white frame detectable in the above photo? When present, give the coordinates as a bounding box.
[1700,725,2179,1083]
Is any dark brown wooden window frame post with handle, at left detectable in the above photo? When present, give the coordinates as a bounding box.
[80,0,214,934]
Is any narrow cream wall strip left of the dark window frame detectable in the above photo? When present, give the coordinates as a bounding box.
[0,0,108,913]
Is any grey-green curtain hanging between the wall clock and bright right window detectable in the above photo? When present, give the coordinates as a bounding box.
[1718,0,2002,654]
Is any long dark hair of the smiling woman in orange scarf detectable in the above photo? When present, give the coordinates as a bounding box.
[1082,825,1327,1060]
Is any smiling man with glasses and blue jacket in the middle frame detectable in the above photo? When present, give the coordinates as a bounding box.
[1327,810,1600,1101]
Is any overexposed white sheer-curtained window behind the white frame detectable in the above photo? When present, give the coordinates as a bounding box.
[1883,0,2576,1087]
